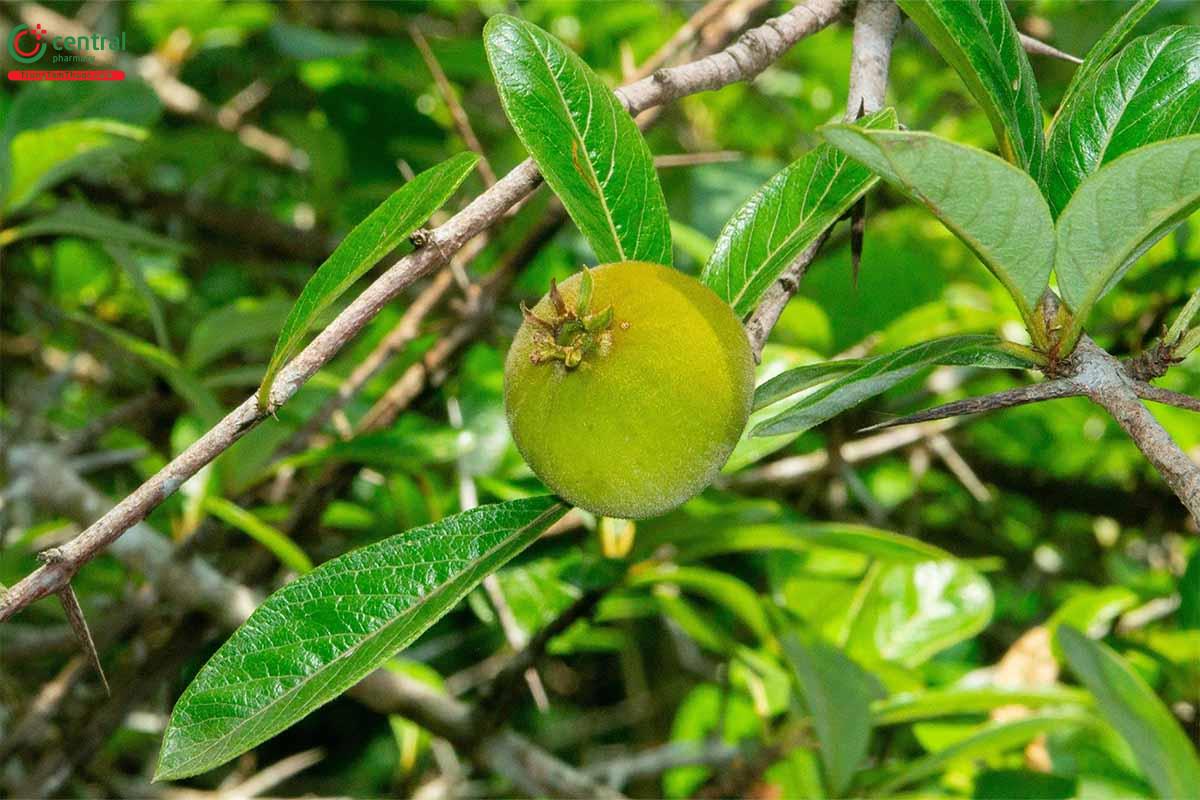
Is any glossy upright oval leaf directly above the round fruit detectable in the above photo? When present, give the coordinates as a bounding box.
[484,14,671,265]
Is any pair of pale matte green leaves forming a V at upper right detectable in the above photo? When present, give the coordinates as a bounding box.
[823,125,1200,345]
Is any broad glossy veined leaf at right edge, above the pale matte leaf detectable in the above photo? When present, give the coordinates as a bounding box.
[1044,28,1200,216]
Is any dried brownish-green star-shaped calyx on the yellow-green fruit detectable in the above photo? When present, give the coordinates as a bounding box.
[521,267,612,369]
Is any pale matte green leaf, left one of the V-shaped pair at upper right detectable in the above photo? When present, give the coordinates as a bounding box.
[821,130,1054,320]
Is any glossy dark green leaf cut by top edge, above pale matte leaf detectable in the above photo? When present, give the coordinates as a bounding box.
[898,0,1045,178]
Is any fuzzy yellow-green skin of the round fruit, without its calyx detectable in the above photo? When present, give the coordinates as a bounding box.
[504,261,754,519]
